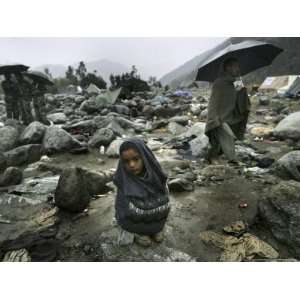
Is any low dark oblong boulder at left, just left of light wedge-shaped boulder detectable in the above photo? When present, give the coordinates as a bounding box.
[4,144,42,166]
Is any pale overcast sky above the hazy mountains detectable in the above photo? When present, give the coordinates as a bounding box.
[0,37,224,78]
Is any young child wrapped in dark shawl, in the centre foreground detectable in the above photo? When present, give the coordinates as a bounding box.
[114,139,170,246]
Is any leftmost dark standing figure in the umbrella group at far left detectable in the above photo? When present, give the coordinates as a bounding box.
[1,73,20,120]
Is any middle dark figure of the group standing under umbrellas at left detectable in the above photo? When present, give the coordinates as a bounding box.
[16,73,33,125]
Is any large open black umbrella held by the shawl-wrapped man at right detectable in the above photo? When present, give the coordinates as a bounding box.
[196,40,283,82]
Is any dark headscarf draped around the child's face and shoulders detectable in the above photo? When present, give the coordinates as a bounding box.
[114,139,167,198]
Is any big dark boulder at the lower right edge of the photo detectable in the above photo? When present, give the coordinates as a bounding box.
[258,181,300,258]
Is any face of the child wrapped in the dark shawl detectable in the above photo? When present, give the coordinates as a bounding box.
[121,148,144,176]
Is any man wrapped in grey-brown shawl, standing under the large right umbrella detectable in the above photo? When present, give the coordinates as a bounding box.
[205,58,250,164]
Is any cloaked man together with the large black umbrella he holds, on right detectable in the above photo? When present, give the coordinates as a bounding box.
[196,39,283,163]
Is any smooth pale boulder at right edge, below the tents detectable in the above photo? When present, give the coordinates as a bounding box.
[273,111,300,140]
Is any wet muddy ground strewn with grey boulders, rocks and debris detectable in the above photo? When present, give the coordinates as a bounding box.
[0,89,300,261]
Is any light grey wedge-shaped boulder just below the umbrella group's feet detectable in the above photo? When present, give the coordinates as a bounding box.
[43,126,81,154]
